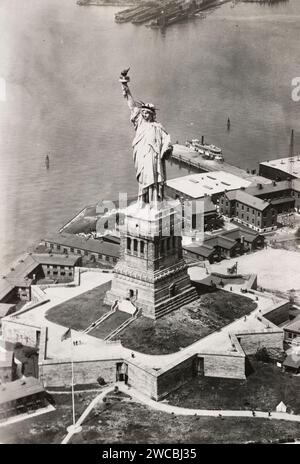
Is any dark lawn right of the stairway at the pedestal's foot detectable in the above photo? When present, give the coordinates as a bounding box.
[117,290,256,354]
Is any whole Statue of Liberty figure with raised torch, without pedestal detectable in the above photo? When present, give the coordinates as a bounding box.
[119,69,173,203]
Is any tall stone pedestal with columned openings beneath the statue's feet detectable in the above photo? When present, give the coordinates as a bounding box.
[105,200,198,319]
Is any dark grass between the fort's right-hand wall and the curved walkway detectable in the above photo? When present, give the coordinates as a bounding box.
[168,358,300,414]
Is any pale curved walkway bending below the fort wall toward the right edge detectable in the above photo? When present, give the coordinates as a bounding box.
[61,382,300,445]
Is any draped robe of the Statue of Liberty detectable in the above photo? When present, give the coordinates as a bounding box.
[131,107,171,197]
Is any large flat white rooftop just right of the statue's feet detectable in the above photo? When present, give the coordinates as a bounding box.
[167,171,251,198]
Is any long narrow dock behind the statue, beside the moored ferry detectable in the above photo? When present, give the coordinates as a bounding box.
[170,144,271,184]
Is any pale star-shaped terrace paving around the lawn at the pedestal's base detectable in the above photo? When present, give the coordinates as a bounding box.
[4,262,286,375]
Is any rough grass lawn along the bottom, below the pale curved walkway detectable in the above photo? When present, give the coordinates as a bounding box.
[70,402,300,444]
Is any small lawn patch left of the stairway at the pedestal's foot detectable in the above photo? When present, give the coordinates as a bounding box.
[46,282,111,330]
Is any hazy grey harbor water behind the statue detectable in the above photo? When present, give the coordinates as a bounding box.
[0,0,300,267]
